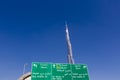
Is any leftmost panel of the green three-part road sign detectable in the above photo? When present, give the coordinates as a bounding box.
[31,63,52,80]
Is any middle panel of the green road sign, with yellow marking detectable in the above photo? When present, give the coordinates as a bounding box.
[52,64,72,80]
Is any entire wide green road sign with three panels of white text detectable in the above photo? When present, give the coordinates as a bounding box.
[31,62,89,80]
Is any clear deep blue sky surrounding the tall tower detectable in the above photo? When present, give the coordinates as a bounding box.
[0,0,120,80]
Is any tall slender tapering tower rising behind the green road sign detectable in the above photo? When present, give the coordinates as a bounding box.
[65,23,74,64]
